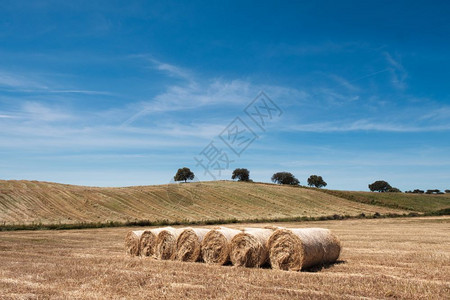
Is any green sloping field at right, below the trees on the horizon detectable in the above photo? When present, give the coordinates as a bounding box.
[323,190,450,213]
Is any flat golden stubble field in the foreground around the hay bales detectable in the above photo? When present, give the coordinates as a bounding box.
[0,217,450,299]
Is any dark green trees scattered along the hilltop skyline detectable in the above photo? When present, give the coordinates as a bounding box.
[174,167,450,194]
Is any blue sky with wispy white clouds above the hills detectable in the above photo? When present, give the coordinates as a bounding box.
[0,0,450,190]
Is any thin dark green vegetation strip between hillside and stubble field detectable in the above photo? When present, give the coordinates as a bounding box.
[0,208,450,231]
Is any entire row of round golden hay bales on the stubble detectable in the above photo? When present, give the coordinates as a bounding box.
[125,227,341,271]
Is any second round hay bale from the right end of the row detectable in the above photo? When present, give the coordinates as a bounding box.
[230,228,273,267]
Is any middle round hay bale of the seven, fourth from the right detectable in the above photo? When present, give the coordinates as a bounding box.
[175,228,210,262]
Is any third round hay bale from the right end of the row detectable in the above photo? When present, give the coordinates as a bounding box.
[201,227,242,265]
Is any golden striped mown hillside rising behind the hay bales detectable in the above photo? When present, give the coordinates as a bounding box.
[0,181,408,225]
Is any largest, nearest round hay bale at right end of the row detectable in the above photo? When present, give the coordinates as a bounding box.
[268,228,341,271]
